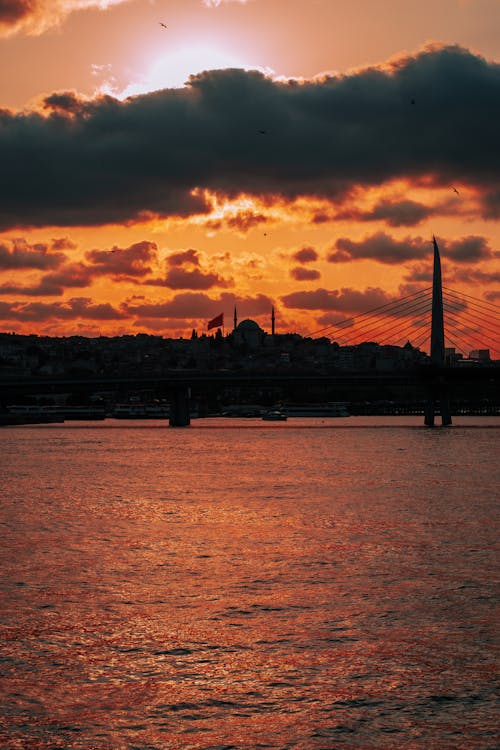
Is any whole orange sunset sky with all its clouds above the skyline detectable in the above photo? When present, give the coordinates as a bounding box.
[0,0,500,356]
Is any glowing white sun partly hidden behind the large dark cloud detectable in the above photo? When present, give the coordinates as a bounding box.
[116,44,269,99]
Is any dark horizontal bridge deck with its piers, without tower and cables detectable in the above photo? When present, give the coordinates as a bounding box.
[0,365,500,426]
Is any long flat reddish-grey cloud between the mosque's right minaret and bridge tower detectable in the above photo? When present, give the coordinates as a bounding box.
[281,287,393,314]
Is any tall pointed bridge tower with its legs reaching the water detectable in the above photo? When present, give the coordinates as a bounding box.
[424,237,451,427]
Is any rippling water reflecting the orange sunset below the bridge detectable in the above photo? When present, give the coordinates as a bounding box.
[0,418,500,750]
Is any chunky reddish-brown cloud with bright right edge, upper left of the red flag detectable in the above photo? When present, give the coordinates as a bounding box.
[85,240,158,279]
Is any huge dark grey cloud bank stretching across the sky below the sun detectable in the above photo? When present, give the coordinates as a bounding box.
[0,46,500,228]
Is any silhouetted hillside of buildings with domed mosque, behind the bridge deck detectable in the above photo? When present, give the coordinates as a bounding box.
[0,320,491,378]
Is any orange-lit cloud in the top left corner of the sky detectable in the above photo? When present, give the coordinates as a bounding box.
[0,0,131,36]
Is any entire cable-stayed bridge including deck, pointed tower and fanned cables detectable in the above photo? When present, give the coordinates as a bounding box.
[0,239,500,427]
